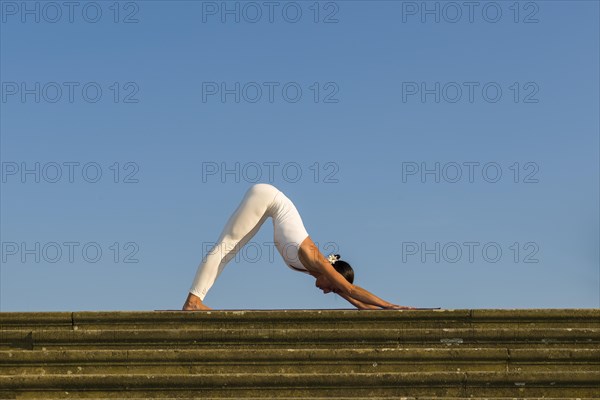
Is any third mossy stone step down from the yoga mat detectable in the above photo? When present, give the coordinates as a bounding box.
[0,348,600,375]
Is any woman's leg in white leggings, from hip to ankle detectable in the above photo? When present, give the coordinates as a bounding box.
[189,183,279,300]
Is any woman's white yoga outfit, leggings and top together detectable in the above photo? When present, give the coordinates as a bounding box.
[190,183,308,300]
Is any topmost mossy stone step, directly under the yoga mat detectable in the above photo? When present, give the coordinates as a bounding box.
[0,309,600,330]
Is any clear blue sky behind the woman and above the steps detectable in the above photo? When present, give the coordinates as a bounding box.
[0,1,600,311]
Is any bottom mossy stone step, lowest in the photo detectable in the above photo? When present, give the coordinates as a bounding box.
[0,372,600,397]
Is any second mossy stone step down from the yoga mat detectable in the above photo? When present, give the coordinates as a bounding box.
[0,327,600,349]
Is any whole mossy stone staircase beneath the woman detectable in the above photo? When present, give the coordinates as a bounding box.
[0,309,600,400]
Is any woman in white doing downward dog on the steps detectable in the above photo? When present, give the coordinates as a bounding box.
[182,183,413,310]
